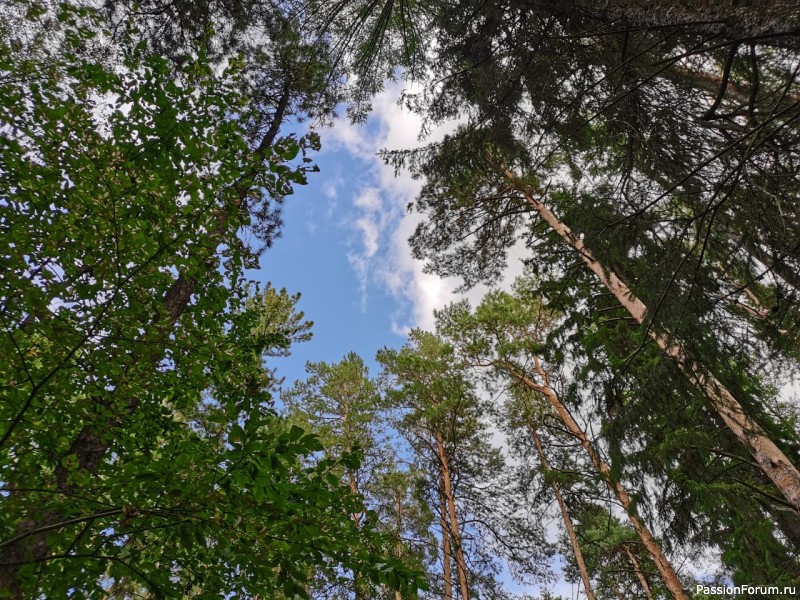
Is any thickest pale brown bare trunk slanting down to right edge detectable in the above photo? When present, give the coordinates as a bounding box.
[505,170,800,514]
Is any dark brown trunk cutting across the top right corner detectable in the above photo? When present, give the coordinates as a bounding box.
[533,0,800,49]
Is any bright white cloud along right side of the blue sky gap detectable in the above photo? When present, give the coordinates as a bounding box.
[322,86,521,336]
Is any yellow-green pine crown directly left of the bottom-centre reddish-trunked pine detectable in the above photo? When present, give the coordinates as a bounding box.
[281,352,432,600]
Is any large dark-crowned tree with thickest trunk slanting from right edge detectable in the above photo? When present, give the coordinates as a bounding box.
[320,2,800,509]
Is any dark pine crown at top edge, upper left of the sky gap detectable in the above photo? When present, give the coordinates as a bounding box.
[101,0,346,131]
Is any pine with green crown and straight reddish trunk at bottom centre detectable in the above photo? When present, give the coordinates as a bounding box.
[378,330,548,600]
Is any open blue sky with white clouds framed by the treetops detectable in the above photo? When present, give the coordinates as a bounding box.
[256,87,583,598]
